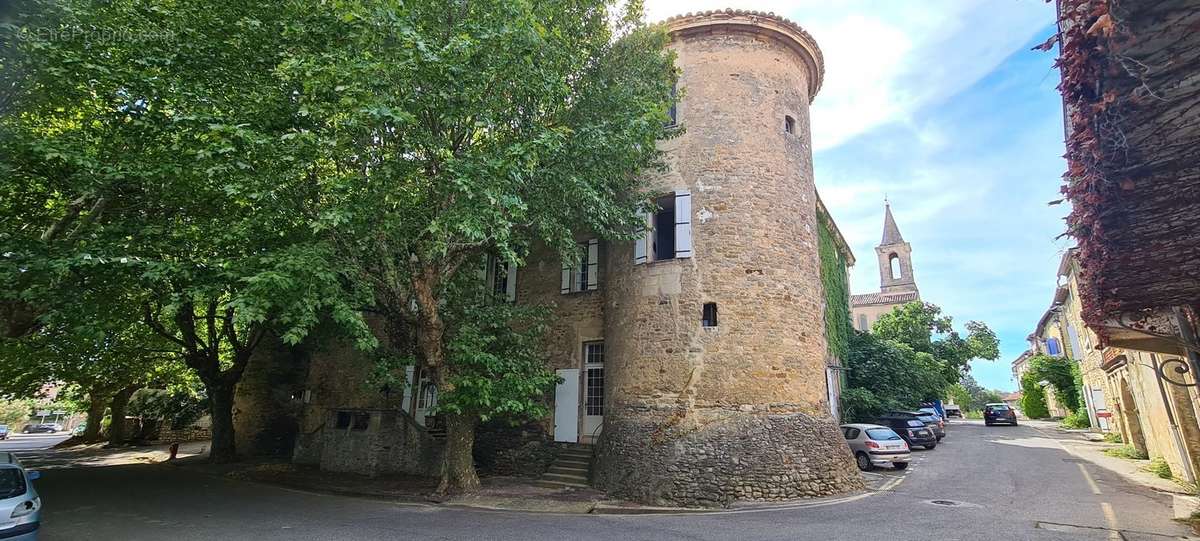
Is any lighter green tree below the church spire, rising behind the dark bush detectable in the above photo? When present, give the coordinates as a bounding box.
[871,302,1000,386]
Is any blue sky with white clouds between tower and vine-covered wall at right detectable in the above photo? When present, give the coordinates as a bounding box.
[646,0,1070,391]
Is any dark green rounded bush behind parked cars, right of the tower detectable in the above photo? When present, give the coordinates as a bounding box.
[842,331,946,421]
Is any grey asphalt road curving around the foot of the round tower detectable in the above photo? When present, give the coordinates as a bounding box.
[16,423,1184,541]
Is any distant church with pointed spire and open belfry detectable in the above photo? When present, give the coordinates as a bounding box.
[850,202,920,332]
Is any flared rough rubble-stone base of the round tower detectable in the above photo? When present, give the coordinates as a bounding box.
[595,410,864,507]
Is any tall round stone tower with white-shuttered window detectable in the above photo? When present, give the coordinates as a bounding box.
[595,10,862,505]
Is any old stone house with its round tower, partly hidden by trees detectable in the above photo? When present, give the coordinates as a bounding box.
[267,10,868,505]
